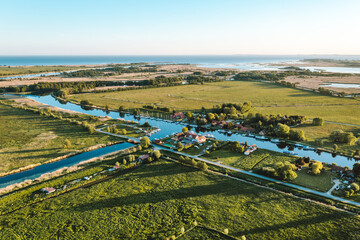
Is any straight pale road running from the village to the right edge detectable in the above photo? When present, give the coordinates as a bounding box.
[155,145,360,207]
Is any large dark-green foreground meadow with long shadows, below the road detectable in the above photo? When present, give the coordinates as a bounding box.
[0,161,360,239]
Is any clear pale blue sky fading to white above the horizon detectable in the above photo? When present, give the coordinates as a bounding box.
[0,0,360,55]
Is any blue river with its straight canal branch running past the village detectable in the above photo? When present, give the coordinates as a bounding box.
[0,95,356,188]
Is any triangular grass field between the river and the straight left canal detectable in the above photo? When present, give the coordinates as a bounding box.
[0,104,119,173]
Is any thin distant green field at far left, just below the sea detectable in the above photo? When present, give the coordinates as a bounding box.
[0,66,84,77]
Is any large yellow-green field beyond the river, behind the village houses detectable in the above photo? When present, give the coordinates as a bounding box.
[69,81,360,124]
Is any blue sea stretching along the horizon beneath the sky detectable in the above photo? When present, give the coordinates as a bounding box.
[0,55,360,73]
